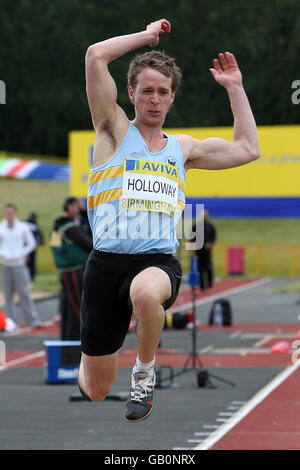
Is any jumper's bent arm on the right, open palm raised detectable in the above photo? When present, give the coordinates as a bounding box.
[177,52,260,170]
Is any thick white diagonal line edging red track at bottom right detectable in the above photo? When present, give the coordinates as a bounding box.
[194,361,300,450]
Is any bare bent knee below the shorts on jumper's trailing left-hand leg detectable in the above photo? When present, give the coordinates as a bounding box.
[78,351,118,401]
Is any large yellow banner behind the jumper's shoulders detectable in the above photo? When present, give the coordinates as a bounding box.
[69,126,300,197]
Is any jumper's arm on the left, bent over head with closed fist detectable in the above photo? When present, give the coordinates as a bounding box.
[85,19,171,130]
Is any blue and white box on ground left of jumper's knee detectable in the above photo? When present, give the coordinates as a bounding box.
[44,341,81,383]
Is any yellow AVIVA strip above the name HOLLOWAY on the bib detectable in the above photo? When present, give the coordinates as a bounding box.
[125,159,179,181]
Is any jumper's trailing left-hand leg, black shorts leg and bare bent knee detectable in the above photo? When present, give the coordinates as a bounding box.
[78,250,126,401]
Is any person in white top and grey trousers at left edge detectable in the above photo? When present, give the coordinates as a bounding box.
[0,203,41,328]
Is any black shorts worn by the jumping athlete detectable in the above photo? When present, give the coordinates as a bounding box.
[81,250,182,356]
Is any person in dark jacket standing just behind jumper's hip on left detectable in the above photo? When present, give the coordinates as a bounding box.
[50,197,93,340]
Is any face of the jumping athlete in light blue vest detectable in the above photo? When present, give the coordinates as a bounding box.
[128,68,175,126]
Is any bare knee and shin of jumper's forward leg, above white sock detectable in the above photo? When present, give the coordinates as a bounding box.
[130,267,171,363]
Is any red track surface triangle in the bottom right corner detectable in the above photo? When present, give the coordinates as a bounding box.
[198,363,300,451]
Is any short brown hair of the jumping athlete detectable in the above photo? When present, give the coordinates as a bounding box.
[127,51,182,91]
